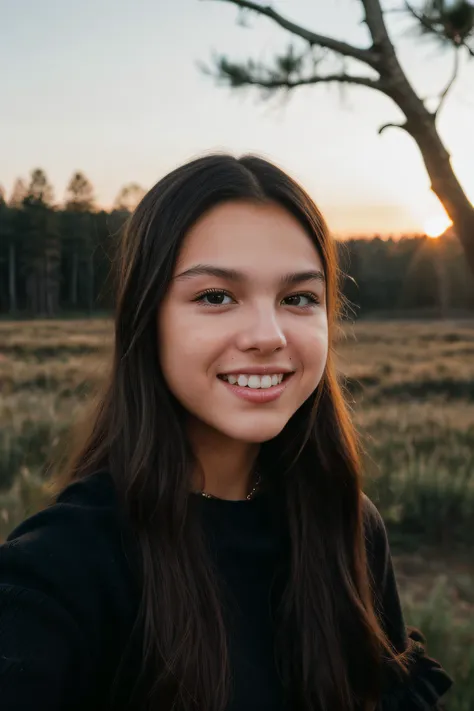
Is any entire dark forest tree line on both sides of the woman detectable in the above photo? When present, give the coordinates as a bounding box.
[0,169,474,318]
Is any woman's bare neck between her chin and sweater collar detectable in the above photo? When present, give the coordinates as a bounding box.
[189,423,260,501]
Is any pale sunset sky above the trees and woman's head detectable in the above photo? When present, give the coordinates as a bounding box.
[0,0,474,236]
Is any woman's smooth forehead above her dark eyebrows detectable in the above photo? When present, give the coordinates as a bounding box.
[176,201,323,273]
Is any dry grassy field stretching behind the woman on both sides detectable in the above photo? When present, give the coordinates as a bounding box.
[0,319,474,711]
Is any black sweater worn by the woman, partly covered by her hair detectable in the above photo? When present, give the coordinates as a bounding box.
[0,472,452,711]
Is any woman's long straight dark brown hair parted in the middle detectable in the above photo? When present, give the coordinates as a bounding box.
[54,154,412,711]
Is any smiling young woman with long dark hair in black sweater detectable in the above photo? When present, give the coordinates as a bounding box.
[0,155,452,711]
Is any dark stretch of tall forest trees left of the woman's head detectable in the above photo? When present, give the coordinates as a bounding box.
[0,169,144,318]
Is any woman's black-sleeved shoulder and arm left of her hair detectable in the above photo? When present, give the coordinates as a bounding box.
[0,472,138,709]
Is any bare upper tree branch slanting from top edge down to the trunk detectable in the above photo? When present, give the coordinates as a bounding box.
[204,0,379,69]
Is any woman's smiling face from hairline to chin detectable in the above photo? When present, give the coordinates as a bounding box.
[158,202,328,443]
